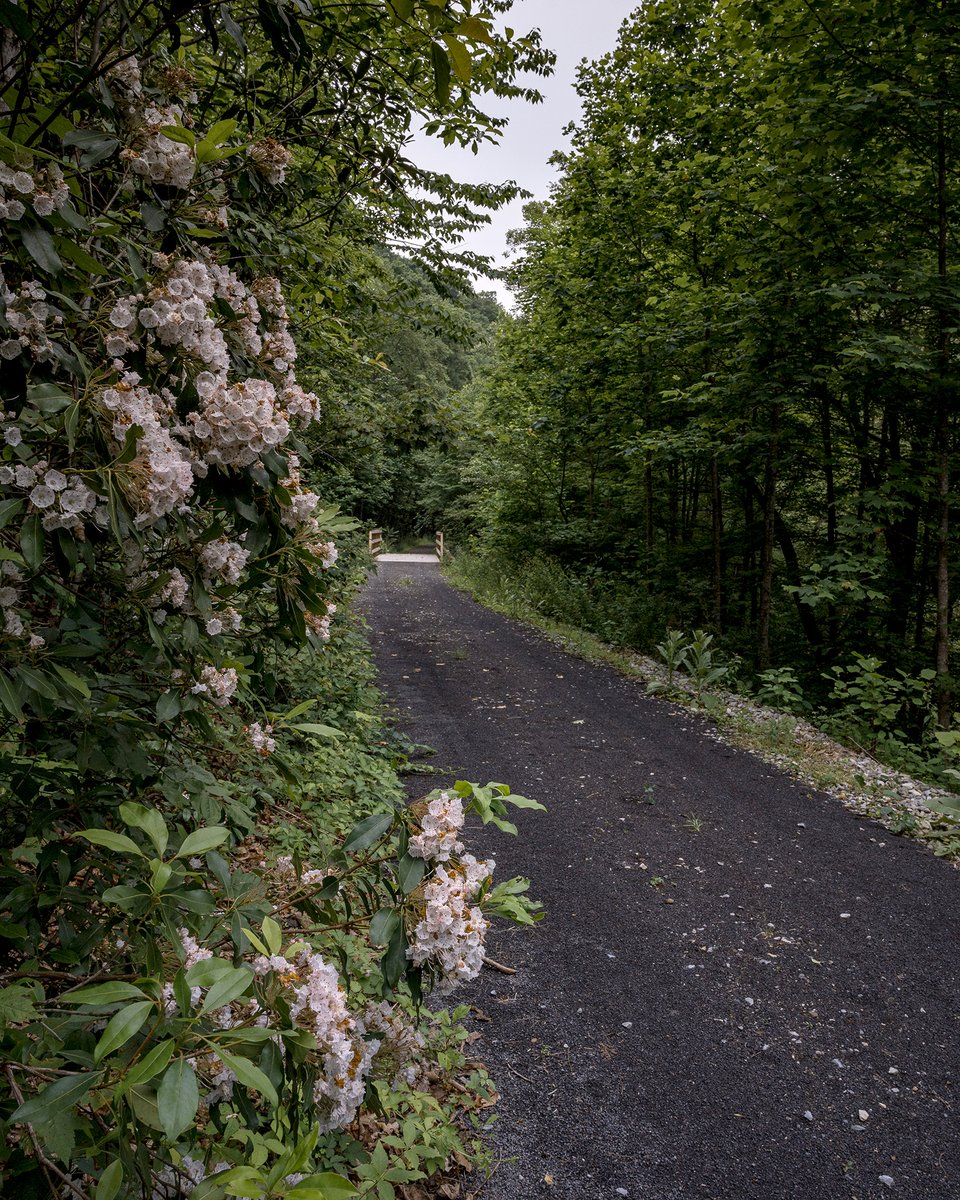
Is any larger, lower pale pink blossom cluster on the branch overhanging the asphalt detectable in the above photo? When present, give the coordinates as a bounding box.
[407,854,496,991]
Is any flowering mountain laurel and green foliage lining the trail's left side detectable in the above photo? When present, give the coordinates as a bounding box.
[0,0,550,1200]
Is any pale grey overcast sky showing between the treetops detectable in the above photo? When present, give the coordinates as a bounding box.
[409,0,637,305]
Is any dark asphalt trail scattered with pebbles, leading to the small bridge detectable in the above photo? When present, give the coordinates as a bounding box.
[365,563,960,1200]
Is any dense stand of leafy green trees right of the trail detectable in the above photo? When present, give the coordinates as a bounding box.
[424,0,960,768]
